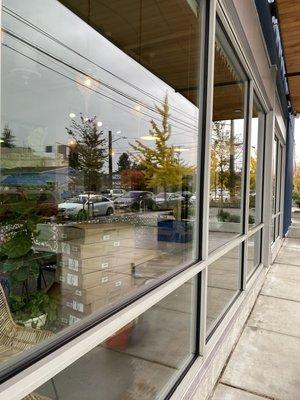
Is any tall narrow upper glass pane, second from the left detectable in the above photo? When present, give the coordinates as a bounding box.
[209,23,246,251]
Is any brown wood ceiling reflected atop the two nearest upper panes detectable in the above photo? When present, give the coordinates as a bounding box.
[60,0,244,120]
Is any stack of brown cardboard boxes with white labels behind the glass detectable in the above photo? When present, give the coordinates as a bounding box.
[56,222,158,325]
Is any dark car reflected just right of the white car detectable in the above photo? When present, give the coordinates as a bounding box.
[114,190,157,211]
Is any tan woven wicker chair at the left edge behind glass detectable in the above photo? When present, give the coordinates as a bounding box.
[0,284,52,363]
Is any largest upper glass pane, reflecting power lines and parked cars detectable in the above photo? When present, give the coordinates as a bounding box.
[0,0,201,368]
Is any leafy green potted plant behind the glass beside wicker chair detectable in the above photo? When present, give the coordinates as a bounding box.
[0,197,56,327]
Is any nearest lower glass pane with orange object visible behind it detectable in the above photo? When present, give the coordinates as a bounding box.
[24,281,195,400]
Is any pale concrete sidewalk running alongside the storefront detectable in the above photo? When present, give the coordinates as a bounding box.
[211,238,300,400]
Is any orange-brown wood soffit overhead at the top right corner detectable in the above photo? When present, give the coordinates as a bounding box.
[276,0,300,113]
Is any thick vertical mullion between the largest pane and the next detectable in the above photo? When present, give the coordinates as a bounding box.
[198,0,216,355]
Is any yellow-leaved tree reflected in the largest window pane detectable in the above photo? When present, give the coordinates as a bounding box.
[131,96,194,198]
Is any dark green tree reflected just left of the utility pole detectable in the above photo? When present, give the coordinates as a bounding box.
[66,114,107,191]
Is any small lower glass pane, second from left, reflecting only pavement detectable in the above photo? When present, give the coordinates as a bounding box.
[206,246,241,333]
